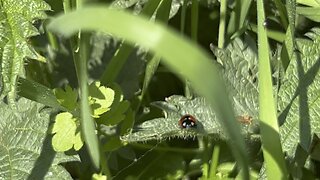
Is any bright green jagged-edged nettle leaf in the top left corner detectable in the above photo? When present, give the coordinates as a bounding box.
[0,0,50,105]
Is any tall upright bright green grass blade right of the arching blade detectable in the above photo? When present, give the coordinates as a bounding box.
[257,0,288,179]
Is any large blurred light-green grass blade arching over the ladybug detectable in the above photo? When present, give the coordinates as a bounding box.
[49,6,249,179]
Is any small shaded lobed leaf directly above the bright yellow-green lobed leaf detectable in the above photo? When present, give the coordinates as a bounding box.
[53,85,78,111]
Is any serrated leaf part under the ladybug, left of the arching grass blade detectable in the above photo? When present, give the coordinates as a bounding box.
[122,96,225,142]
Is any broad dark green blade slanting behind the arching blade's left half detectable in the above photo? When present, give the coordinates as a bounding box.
[100,0,161,84]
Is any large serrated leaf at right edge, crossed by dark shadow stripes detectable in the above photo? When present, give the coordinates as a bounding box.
[278,28,320,156]
